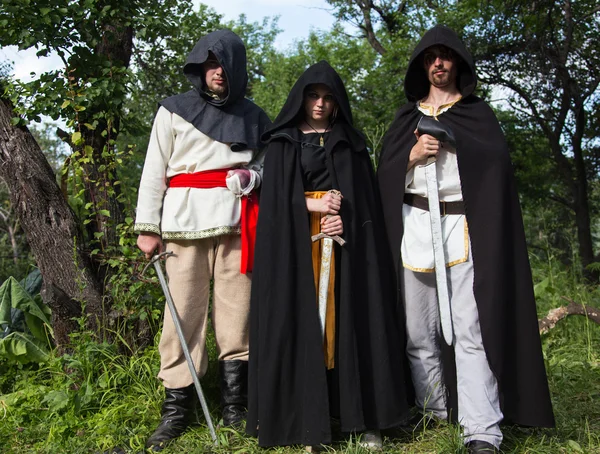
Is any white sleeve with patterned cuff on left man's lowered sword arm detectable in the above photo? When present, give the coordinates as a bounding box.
[134,106,175,235]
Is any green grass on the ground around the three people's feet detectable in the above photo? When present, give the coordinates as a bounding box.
[0,267,600,454]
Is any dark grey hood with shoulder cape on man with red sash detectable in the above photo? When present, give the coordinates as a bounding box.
[159,30,271,151]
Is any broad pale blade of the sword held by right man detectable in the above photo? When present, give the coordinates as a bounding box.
[425,161,454,345]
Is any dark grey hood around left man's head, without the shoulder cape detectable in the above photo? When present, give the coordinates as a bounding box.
[183,30,248,106]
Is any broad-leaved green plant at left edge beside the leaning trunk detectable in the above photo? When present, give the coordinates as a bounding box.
[0,270,52,364]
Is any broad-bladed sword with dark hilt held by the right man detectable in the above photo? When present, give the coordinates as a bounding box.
[417,116,456,345]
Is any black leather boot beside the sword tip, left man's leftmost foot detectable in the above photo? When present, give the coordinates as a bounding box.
[146,383,196,451]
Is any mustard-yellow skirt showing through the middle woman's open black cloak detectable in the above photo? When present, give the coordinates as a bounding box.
[304,191,335,369]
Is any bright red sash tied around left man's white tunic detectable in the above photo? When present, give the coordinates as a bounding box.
[168,169,258,274]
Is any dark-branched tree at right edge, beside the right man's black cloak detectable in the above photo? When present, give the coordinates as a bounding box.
[465,0,600,277]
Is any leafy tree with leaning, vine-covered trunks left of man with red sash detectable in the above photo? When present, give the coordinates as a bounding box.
[0,0,241,345]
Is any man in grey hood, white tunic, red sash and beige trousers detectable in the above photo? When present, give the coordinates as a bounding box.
[135,30,270,451]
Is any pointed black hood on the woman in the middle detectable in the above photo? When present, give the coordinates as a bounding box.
[262,60,365,150]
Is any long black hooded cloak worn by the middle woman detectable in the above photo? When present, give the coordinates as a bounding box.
[246,61,408,446]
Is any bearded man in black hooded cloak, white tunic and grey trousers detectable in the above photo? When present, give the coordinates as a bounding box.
[378,26,554,453]
